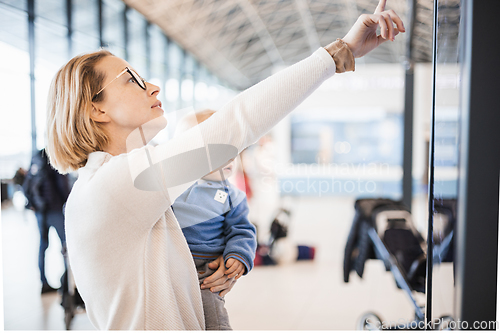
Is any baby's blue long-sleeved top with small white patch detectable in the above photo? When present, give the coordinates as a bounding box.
[172,179,257,274]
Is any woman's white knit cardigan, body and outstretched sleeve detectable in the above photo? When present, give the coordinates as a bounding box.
[66,48,335,330]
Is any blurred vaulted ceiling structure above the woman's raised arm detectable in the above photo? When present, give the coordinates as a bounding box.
[124,0,460,89]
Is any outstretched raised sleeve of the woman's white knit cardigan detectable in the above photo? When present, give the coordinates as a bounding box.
[127,48,336,204]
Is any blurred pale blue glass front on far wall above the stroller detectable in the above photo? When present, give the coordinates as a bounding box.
[290,109,403,200]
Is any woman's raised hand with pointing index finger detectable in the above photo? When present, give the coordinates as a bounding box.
[342,0,405,58]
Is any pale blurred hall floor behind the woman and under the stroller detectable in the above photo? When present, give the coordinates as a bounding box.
[1,197,452,330]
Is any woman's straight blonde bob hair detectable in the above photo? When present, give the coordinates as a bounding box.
[47,50,113,174]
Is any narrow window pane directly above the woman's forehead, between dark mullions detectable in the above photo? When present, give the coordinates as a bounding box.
[102,0,125,58]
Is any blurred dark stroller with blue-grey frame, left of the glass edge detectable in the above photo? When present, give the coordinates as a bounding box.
[344,199,427,330]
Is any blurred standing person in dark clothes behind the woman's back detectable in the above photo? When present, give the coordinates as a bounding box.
[23,149,70,294]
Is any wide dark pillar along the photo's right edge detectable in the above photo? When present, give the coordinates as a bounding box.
[455,0,500,329]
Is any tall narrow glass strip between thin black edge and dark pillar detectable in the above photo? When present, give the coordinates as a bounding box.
[432,0,460,319]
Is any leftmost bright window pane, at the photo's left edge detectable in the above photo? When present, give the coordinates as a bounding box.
[0,4,31,179]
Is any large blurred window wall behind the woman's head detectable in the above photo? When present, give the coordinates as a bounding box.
[0,0,234,179]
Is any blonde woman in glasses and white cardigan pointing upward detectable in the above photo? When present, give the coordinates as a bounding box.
[48,0,404,330]
